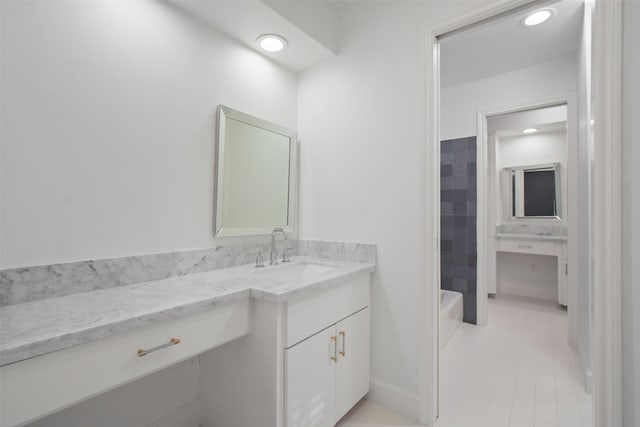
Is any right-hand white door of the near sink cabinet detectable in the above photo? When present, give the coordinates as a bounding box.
[334,308,369,422]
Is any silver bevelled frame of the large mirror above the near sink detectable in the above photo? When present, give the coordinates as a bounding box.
[213,105,298,237]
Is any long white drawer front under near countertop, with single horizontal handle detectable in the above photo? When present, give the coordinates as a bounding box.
[0,299,251,427]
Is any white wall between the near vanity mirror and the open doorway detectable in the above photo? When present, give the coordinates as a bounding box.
[298,1,488,417]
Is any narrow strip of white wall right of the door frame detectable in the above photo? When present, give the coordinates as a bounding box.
[620,1,640,427]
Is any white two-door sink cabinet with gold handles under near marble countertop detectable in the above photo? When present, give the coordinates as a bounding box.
[200,272,370,427]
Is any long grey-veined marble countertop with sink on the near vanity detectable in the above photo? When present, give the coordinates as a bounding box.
[0,257,375,365]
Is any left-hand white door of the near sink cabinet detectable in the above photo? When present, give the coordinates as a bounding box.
[285,326,337,427]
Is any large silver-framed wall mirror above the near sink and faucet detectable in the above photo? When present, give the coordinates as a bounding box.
[214,105,297,236]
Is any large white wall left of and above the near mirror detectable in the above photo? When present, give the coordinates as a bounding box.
[0,0,297,268]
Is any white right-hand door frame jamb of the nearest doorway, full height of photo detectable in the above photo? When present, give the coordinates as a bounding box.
[592,0,623,427]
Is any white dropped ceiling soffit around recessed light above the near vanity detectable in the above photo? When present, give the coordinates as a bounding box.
[168,0,338,71]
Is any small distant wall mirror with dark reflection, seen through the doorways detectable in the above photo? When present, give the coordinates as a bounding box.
[502,163,562,220]
